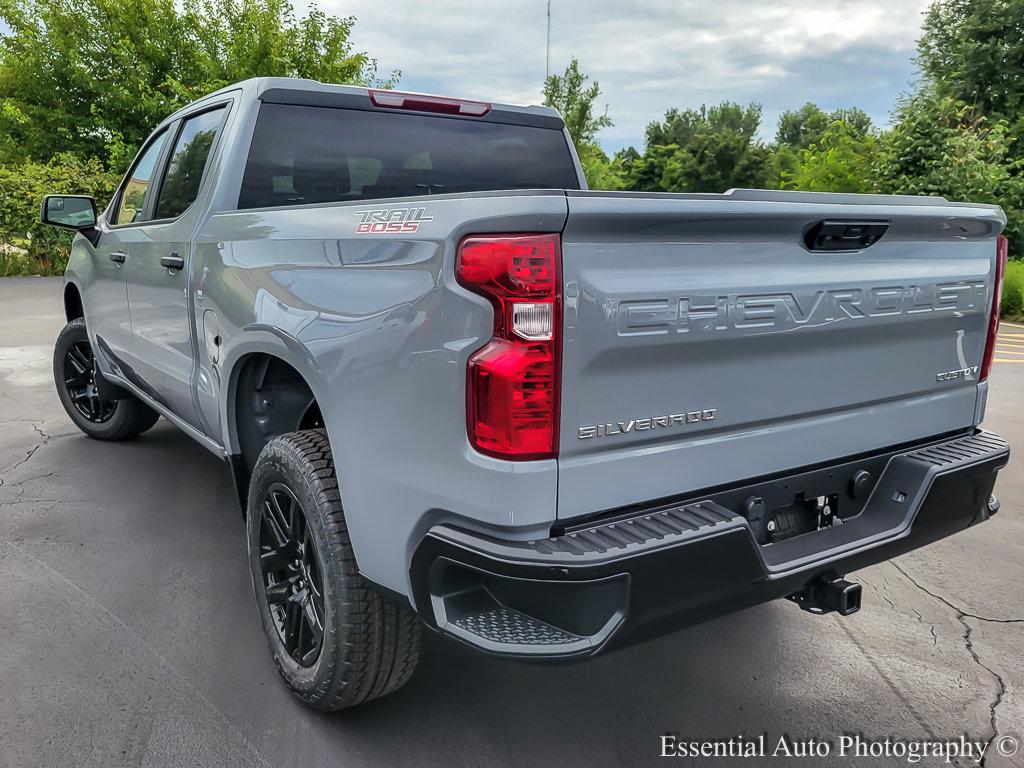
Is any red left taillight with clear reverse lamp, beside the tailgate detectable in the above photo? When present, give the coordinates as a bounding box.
[456,234,561,460]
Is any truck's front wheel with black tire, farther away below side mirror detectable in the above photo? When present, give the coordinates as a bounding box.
[53,317,160,440]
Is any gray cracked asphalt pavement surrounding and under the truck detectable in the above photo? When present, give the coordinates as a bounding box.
[0,279,1024,768]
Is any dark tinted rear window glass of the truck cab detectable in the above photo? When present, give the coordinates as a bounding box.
[239,104,580,208]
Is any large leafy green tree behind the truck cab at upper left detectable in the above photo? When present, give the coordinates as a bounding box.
[0,0,391,166]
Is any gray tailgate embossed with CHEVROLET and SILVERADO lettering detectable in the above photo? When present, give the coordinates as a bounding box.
[558,191,1005,518]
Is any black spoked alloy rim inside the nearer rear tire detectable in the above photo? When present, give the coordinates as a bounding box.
[259,482,325,667]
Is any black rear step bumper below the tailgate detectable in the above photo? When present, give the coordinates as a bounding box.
[412,431,1010,658]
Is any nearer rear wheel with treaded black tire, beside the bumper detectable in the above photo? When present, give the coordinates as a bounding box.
[247,429,421,711]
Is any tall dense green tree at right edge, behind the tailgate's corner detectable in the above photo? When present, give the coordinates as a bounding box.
[905,0,1024,256]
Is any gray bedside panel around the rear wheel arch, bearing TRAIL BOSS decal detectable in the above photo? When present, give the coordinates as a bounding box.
[195,193,566,593]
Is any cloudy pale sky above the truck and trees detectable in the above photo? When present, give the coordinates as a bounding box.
[315,0,928,151]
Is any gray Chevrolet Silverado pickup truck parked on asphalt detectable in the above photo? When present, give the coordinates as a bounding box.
[41,78,1009,710]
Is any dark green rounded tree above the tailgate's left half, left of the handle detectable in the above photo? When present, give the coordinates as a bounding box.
[623,101,771,193]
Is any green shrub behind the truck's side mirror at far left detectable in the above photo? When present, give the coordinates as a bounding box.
[0,155,119,276]
